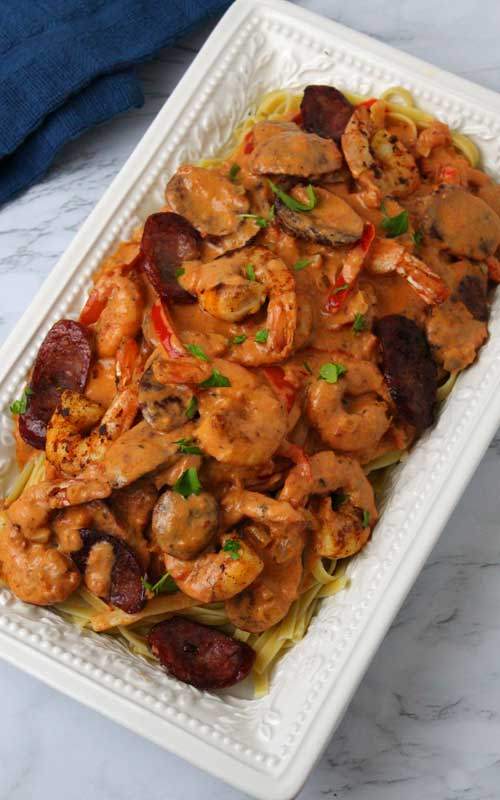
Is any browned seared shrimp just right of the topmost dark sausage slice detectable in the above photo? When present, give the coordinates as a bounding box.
[342,103,420,207]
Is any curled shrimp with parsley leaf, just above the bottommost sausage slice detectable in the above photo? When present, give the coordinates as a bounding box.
[165,533,264,603]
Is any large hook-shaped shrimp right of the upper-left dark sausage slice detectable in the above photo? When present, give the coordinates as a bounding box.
[179,247,297,366]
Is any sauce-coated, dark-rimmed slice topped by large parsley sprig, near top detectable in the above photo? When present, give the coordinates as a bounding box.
[276,186,363,247]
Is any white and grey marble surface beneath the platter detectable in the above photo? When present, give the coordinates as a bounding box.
[0,0,500,800]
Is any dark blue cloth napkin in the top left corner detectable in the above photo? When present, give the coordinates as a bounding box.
[0,0,230,203]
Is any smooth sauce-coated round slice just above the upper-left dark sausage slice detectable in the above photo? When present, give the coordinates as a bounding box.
[165,164,249,236]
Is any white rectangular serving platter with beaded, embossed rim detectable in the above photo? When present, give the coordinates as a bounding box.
[0,0,500,800]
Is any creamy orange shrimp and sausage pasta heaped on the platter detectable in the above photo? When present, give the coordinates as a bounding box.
[0,85,500,696]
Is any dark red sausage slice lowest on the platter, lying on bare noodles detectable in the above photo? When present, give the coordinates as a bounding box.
[148,617,256,689]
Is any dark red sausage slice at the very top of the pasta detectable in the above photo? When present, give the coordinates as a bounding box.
[300,86,354,142]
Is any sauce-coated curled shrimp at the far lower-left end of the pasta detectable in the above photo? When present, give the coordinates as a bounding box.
[0,522,81,606]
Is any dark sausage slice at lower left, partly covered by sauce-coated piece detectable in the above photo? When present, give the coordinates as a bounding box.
[71,528,146,614]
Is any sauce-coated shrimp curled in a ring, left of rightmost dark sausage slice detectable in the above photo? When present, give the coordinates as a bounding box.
[307,357,391,453]
